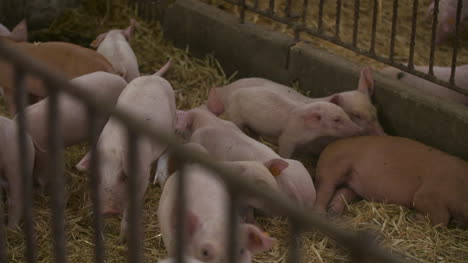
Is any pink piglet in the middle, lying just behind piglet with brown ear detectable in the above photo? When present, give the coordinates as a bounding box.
[177,106,315,212]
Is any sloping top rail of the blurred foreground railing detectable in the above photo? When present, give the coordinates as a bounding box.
[0,40,401,262]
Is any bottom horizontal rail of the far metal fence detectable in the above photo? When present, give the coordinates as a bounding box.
[220,0,468,96]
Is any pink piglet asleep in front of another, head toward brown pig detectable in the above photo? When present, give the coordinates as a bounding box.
[211,87,362,158]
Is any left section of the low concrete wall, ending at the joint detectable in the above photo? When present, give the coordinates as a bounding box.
[163,0,294,82]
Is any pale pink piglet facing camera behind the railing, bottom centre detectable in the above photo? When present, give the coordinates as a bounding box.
[158,144,275,263]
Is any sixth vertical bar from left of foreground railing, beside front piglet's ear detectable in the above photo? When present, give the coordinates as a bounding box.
[227,192,239,263]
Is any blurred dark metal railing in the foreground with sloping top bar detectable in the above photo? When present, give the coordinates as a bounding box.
[0,36,401,263]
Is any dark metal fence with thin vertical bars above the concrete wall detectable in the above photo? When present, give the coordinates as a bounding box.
[131,0,468,95]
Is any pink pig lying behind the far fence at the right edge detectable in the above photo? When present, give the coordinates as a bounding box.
[381,65,468,105]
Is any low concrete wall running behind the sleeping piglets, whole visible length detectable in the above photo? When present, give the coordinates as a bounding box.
[162,0,468,160]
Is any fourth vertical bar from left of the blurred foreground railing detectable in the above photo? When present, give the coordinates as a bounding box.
[124,131,143,263]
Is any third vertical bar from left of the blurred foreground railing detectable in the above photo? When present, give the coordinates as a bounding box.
[88,107,104,263]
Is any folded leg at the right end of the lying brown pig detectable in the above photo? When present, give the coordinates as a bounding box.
[413,188,450,226]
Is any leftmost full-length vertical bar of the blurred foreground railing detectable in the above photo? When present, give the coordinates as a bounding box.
[15,68,36,263]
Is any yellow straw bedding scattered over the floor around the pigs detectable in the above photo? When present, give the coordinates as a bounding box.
[0,0,468,262]
